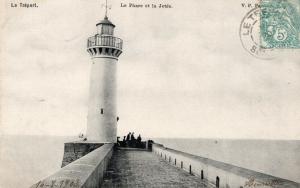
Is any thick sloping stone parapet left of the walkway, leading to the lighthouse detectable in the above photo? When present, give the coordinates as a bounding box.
[31,144,114,188]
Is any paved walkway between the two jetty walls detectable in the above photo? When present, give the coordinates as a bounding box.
[102,150,212,188]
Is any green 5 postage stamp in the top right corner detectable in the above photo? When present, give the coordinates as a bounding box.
[260,0,300,49]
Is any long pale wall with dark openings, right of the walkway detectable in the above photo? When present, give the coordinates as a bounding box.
[152,144,300,188]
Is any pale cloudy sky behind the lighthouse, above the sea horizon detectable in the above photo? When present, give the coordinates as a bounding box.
[0,0,300,139]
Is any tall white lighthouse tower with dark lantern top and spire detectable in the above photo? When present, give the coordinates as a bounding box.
[86,4,123,143]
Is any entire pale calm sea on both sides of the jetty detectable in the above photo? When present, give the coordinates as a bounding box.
[0,135,300,188]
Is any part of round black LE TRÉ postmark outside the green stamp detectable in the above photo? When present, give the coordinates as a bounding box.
[239,7,274,59]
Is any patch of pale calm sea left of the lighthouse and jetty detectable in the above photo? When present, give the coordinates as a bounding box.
[0,136,75,188]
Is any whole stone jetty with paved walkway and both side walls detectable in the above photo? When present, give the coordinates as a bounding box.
[31,143,300,188]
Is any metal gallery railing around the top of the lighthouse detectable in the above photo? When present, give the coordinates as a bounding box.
[87,35,123,50]
